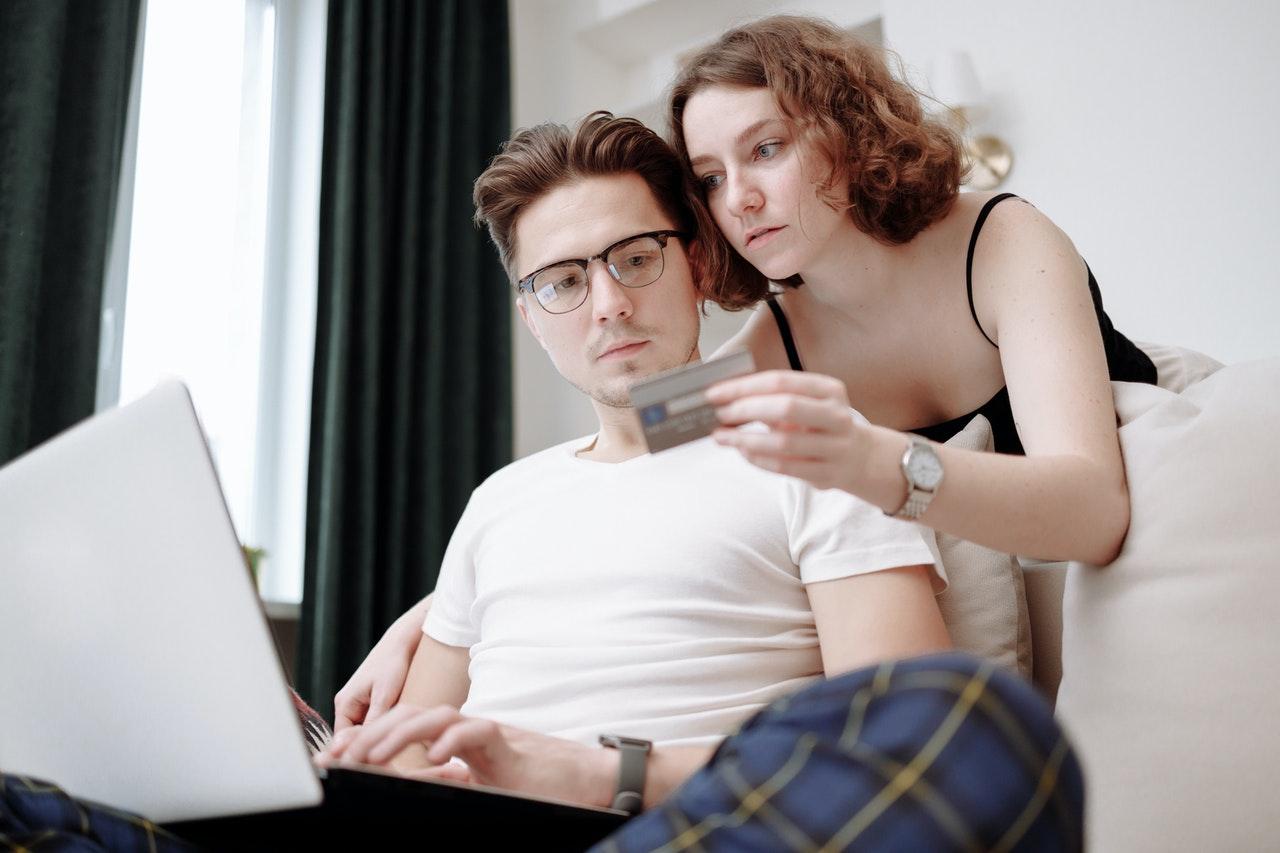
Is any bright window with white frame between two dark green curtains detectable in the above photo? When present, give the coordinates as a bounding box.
[100,0,324,602]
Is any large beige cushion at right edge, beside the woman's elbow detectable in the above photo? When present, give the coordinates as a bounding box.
[1057,360,1280,853]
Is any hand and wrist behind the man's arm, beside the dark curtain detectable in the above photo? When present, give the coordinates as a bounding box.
[333,596,431,733]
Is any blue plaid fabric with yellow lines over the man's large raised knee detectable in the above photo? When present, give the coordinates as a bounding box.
[593,654,1084,853]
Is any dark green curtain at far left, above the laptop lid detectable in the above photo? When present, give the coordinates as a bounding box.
[0,0,140,464]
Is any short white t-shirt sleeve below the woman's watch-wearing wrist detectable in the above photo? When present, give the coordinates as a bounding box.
[788,471,947,593]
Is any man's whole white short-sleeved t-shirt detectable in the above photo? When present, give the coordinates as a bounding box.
[424,438,945,745]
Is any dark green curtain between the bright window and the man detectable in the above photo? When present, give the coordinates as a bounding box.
[297,0,512,716]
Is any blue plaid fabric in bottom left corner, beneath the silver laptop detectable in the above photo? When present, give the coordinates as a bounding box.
[0,774,196,853]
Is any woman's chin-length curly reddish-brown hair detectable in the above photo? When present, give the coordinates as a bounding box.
[668,15,963,310]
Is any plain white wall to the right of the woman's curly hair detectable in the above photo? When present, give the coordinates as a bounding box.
[883,0,1280,361]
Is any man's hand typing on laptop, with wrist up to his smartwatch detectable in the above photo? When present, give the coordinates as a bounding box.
[316,703,618,806]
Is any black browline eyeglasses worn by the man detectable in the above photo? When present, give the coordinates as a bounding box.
[516,231,685,314]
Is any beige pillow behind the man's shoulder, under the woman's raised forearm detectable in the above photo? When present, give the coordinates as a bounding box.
[924,415,1032,678]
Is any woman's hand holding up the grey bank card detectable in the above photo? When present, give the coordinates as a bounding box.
[707,370,868,493]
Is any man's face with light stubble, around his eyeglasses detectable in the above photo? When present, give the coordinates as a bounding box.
[515,174,699,409]
